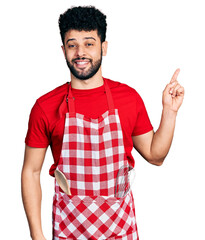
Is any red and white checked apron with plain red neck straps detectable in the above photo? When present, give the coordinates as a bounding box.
[53,79,139,240]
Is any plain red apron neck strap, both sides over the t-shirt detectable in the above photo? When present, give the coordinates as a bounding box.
[67,79,115,113]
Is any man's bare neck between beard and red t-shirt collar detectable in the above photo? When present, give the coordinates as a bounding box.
[71,68,104,89]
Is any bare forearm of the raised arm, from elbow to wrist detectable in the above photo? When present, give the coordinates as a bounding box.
[150,108,177,165]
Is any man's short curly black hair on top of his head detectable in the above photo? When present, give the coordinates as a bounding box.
[58,6,107,44]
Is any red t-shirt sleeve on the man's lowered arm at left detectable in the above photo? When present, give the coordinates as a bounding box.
[25,101,50,148]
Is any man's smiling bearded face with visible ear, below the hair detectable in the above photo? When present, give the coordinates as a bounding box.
[62,30,107,80]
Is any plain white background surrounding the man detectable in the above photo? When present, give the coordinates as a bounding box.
[0,0,205,240]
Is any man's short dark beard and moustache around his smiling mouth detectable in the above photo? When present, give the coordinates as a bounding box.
[66,51,102,80]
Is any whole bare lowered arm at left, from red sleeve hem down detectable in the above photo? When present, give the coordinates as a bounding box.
[21,146,46,240]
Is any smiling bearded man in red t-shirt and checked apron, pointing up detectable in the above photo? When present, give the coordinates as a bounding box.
[22,7,184,240]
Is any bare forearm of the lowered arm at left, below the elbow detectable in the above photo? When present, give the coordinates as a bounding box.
[22,169,45,240]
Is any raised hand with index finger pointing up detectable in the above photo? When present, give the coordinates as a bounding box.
[162,69,184,112]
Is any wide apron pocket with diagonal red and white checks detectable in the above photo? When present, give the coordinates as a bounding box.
[56,193,135,239]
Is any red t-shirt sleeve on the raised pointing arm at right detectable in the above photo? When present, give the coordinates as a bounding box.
[132,93,153,136]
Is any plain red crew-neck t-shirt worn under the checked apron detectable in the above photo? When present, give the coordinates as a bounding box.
[25,79,153,176]
